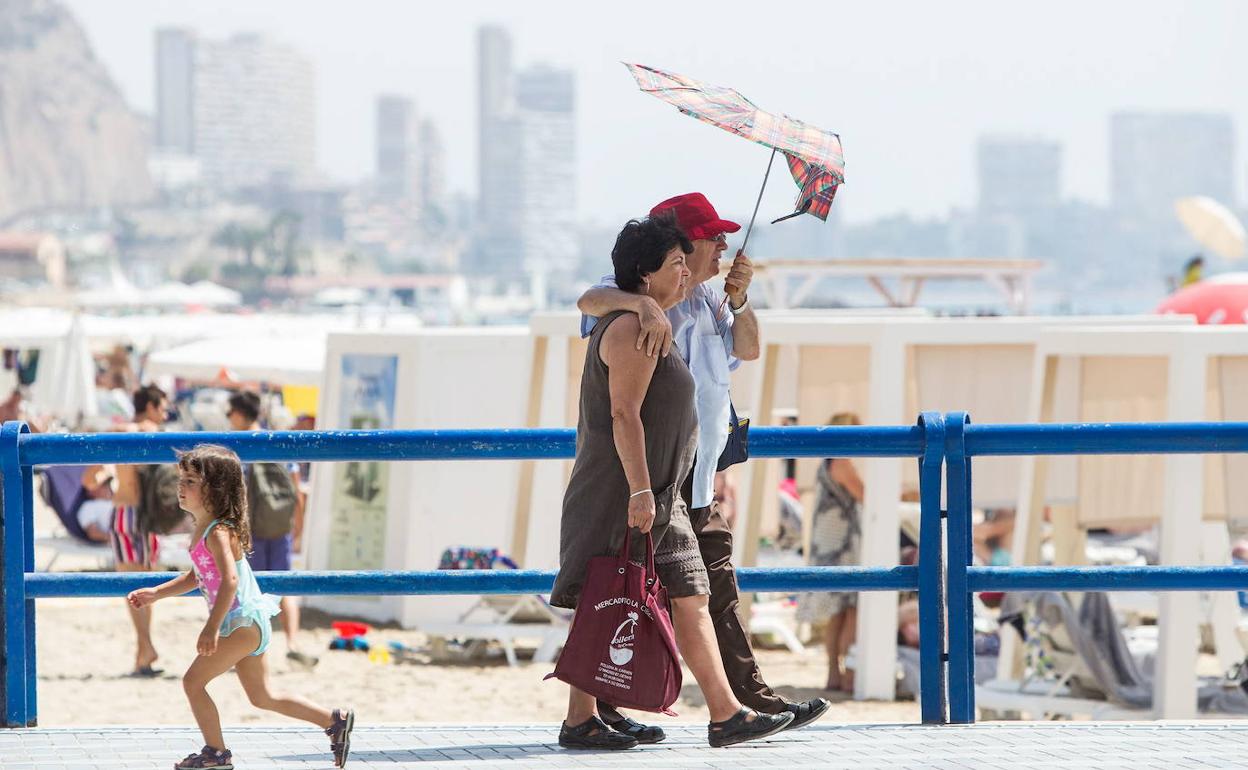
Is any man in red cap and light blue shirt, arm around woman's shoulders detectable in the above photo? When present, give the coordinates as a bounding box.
[577,192,831,743]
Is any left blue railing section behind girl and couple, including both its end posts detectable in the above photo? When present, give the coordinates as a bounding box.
[0,413,946,726]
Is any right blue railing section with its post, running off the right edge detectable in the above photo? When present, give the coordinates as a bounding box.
[938,412,1248,724]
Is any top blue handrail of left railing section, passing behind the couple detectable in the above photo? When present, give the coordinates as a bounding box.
[17,426,924,465]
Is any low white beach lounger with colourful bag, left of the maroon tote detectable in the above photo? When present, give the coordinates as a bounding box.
[418,548,572,666]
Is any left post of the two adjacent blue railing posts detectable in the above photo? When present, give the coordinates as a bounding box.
[919,412,948,725]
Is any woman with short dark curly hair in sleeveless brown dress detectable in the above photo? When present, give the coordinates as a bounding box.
[550,216,794,749]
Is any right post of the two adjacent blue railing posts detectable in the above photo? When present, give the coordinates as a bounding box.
[945,412,975,724]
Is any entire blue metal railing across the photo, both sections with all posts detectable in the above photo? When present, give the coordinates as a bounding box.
[14,412,1248,726]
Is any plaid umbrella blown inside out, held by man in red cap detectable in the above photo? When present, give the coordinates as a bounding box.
[624,62,845,242]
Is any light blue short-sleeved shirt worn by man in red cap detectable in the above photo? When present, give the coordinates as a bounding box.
[580,276,741,508]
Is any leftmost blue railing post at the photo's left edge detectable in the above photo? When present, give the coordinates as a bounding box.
[0,422,32,728]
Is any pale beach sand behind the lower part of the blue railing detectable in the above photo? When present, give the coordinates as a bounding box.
[36,597,919,726]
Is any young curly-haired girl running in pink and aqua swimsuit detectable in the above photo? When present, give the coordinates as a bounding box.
[127,444,354,770]
